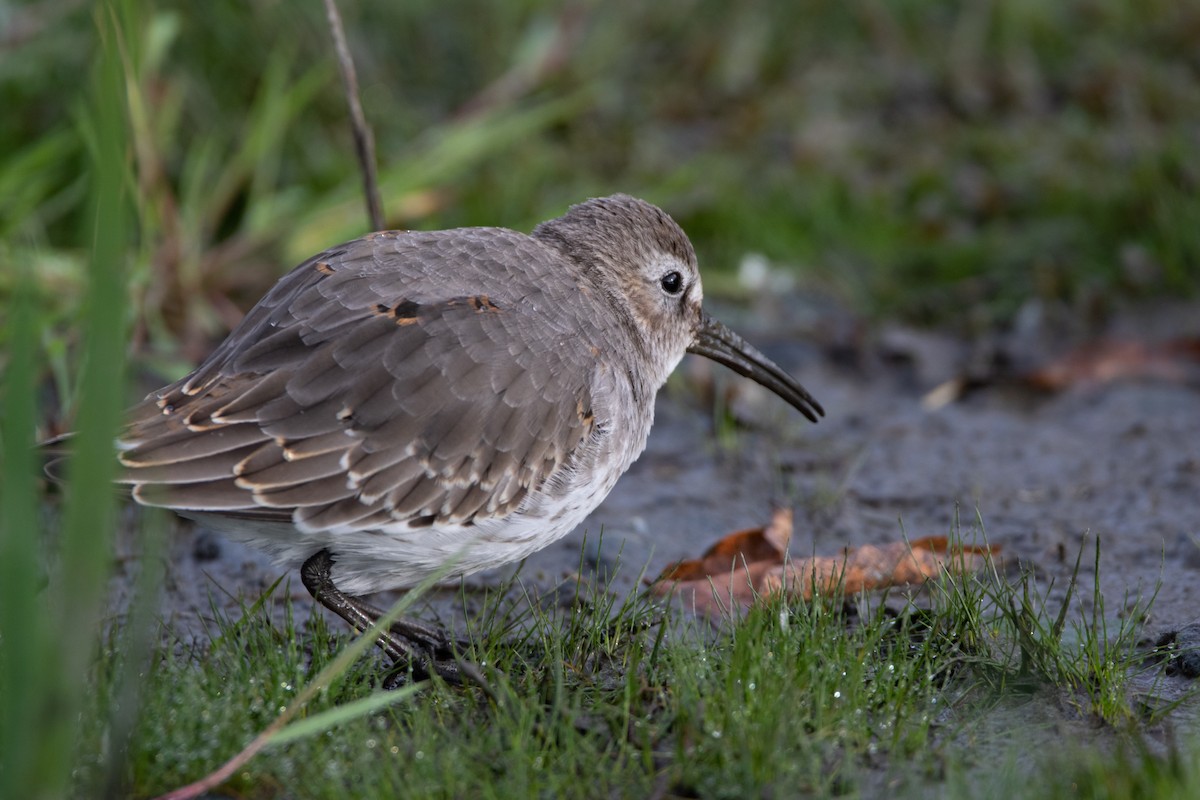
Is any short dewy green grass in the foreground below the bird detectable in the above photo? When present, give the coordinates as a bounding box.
[42,522,1196,798]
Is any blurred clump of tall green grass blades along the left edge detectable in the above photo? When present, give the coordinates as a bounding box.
[0,0,137,800]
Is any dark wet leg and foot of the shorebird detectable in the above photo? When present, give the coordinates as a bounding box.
[300,549,477,693]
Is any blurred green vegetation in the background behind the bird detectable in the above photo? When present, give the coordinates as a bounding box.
[0,0,1200,410]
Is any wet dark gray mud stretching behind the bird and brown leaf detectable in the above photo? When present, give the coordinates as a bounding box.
[117,296,1200,762]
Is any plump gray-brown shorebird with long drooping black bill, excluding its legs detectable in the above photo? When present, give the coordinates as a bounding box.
[87,196,822,681]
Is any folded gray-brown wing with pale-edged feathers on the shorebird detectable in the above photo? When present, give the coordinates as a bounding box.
[120,231,595,531]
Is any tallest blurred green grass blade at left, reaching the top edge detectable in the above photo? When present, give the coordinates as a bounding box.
[37,2,132,796]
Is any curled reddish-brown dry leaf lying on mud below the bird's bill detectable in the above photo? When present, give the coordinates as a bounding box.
[652,510,995,615]
